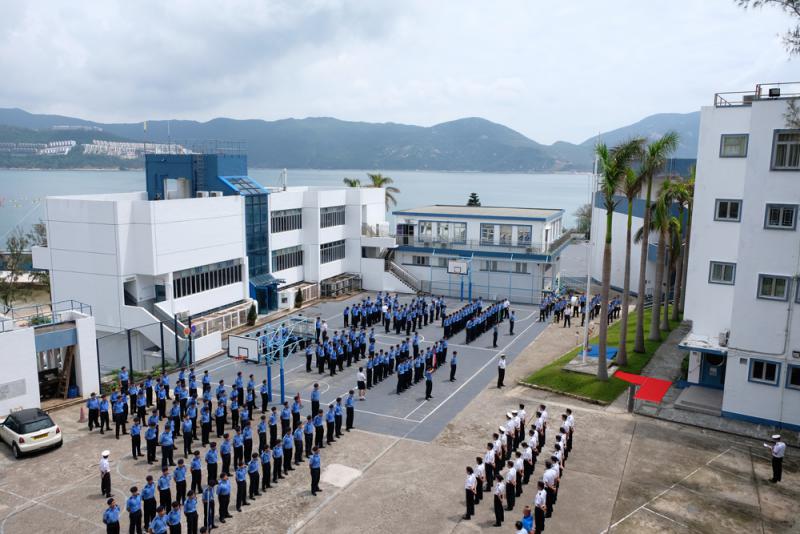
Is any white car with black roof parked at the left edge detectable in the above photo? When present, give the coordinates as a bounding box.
[0,408,63,458]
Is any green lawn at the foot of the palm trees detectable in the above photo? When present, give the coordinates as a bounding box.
[525,308,680,404]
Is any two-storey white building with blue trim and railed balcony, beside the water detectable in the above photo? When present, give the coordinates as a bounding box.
[391,205,568,303]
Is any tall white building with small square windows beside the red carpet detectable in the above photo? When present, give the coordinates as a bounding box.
[682,85,800,436]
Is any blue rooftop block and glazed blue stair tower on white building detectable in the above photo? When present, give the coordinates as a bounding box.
[145,154,279,313]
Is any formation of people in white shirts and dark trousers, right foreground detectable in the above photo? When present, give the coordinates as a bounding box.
[463,404,575,534]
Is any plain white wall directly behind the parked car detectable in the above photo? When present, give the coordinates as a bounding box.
[0,328,39,415]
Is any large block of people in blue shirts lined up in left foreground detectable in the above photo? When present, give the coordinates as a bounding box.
[94,368,355,534]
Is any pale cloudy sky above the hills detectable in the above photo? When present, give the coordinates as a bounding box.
[0,0,800,143]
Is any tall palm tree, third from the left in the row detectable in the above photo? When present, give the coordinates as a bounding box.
[633,132,678,353]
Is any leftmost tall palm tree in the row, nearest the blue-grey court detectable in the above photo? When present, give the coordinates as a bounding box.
[595,139,642,380]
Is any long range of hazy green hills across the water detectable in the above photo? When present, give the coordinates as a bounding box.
[0,109,699,172]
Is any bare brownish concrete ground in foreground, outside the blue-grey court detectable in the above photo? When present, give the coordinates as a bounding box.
[0,296,800,534]
